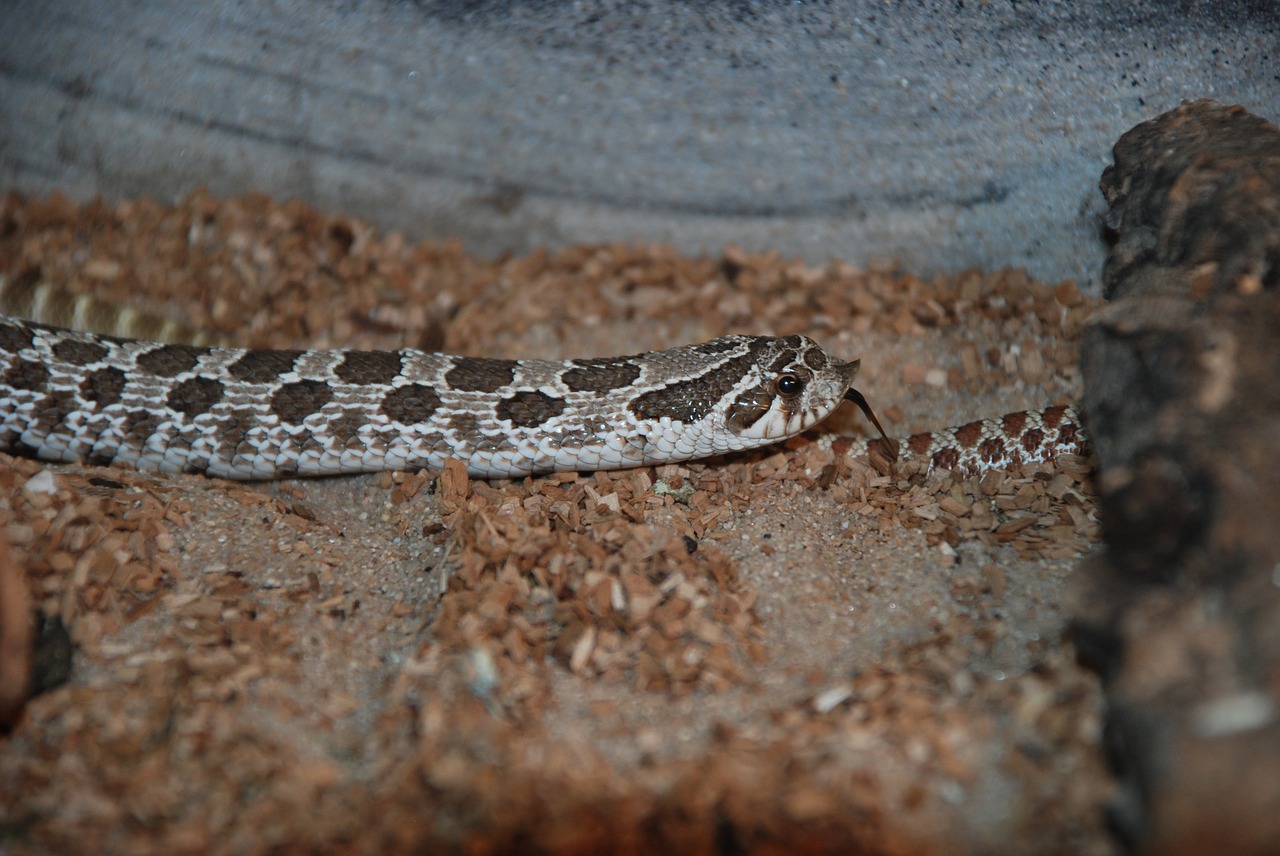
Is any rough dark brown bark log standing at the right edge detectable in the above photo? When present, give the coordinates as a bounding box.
[1078,101,1280,853]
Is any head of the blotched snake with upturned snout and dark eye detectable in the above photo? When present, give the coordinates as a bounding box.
[726,335,860,445]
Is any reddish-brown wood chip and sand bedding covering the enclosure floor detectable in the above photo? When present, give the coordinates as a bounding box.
[0,192,1111,853]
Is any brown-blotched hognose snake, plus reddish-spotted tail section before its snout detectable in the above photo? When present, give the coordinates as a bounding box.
[0,278,1087,480]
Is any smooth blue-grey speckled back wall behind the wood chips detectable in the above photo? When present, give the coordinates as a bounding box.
[0,0,1280,287]
